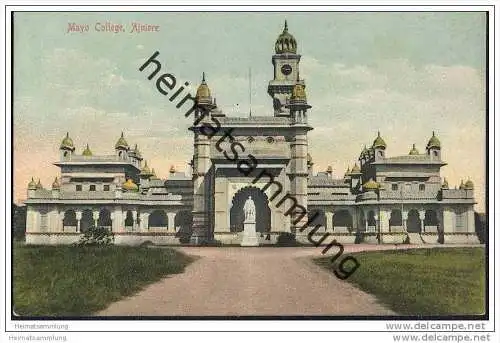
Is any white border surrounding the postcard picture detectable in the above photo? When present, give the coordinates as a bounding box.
[0,1,498,341]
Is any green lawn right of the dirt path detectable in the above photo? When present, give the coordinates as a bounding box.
[314,248,486,315]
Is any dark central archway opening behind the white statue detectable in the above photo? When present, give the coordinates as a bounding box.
[229,187,271,232]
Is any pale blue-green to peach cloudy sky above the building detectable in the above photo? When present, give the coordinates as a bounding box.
[13,12,487,211]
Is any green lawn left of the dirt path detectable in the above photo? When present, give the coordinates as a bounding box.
[13,244,194,316]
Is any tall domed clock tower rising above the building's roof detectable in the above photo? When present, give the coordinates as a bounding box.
[267,21,305,117]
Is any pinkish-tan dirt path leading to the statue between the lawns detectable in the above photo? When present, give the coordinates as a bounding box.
[98,245,402,316]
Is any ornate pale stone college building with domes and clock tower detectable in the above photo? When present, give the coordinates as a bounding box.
[25,23,478,245]
